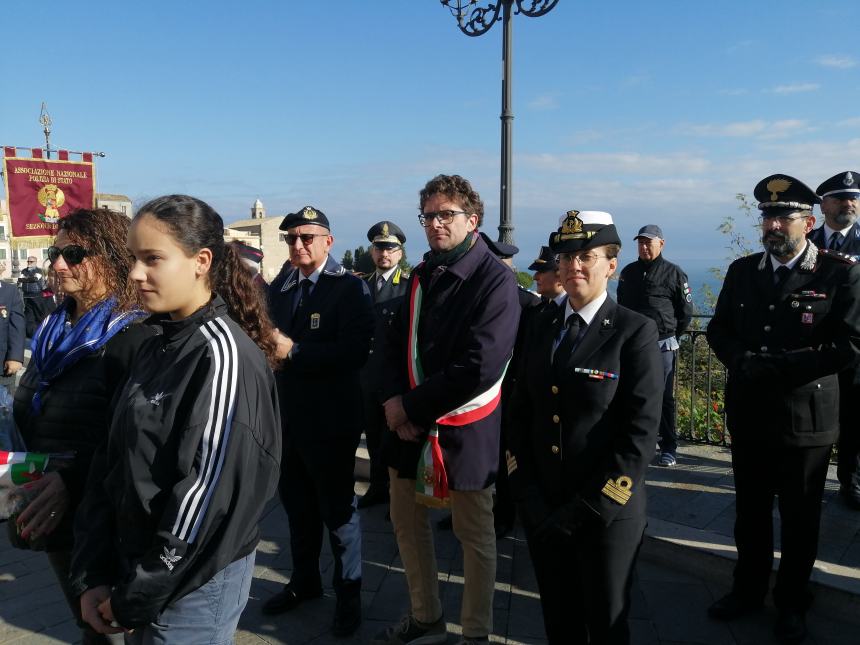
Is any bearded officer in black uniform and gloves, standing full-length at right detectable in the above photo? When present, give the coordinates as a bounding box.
[708,174,860,642]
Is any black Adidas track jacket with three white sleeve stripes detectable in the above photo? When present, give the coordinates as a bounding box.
[71,296,281,628]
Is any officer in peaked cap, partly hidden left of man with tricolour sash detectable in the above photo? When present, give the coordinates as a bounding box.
[358,221,409,508]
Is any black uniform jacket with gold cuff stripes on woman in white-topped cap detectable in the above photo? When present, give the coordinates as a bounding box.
[508,297,663,526]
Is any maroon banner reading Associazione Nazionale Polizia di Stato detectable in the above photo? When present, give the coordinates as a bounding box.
[3,148,96,248]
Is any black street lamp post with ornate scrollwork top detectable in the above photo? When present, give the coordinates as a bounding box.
[440,0,558,244]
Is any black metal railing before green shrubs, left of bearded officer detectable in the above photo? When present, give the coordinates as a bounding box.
[674,315,730,446]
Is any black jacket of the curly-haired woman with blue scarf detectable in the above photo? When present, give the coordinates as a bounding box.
[13,323,155,551]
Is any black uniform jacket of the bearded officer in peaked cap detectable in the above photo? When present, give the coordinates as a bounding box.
[708,242,860,446]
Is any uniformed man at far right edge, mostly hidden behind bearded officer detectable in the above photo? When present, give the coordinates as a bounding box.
[809,170,860,510]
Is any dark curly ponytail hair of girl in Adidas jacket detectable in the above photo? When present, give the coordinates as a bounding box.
[134,195,278,367]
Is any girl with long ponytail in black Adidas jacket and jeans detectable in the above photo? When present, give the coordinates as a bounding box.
[72,195,281,645]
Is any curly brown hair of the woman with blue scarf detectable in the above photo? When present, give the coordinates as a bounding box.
[57,208,140,311]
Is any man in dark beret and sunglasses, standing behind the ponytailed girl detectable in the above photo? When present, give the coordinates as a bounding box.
[263,206,374,636]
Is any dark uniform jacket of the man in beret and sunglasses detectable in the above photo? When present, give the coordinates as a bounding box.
[269,256,374,451]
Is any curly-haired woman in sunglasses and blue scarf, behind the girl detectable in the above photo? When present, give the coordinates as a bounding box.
[9,209,154,643]
